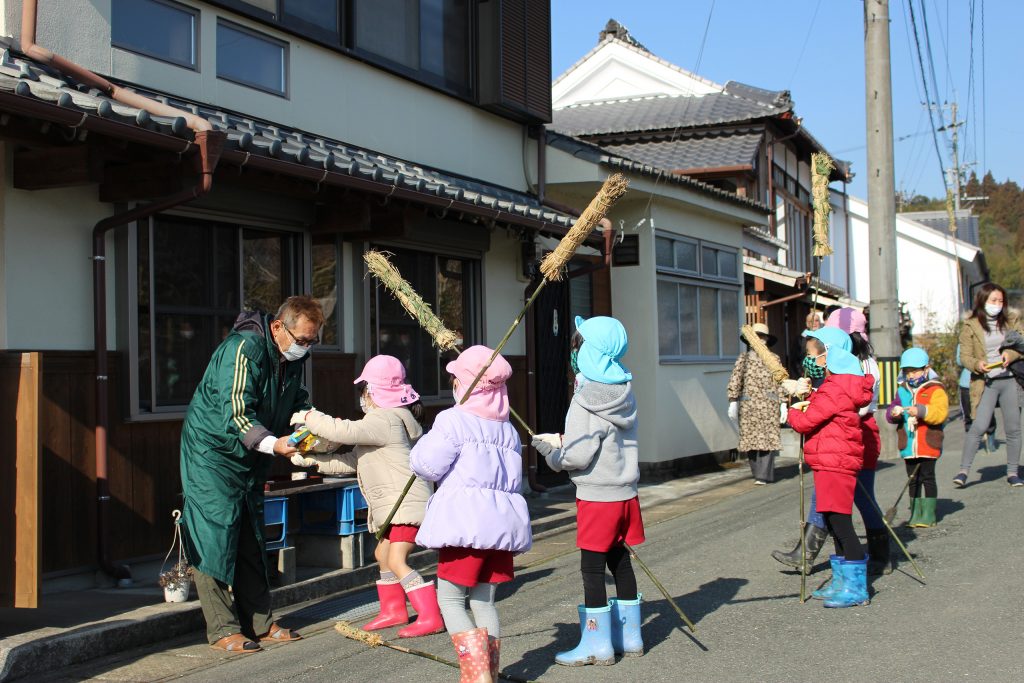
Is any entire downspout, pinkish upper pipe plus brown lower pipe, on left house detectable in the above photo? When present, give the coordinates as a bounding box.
[20,0,225,583]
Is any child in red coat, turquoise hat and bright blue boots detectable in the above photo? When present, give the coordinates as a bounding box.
[788,328,874,607]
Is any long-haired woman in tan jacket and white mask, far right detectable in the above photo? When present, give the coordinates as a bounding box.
[953,283,1024,488]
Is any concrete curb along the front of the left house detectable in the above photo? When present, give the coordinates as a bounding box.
[0,468,746,681]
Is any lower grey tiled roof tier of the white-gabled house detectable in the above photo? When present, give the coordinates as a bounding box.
[601,130,764,171]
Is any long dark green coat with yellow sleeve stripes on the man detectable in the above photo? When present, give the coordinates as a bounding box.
[181,312,311,585]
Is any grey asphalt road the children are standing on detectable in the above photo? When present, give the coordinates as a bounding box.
[36,422,1024,683]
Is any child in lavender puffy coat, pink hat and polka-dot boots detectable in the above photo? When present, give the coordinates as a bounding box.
[409,346,532,681]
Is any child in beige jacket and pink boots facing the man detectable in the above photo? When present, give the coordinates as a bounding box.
[293,355,444,638]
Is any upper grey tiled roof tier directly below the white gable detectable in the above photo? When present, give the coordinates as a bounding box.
[551,83,793,136]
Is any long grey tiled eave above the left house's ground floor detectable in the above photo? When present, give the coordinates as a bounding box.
[0,49,574,232]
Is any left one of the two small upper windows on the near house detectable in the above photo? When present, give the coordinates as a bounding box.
[111,0,199,69]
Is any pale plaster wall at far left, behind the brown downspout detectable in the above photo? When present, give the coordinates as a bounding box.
[3,179,117,350]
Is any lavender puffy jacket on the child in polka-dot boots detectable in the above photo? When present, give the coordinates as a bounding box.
[409,407,532,553]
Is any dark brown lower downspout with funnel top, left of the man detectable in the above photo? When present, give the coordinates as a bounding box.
[92,131,224,582]
